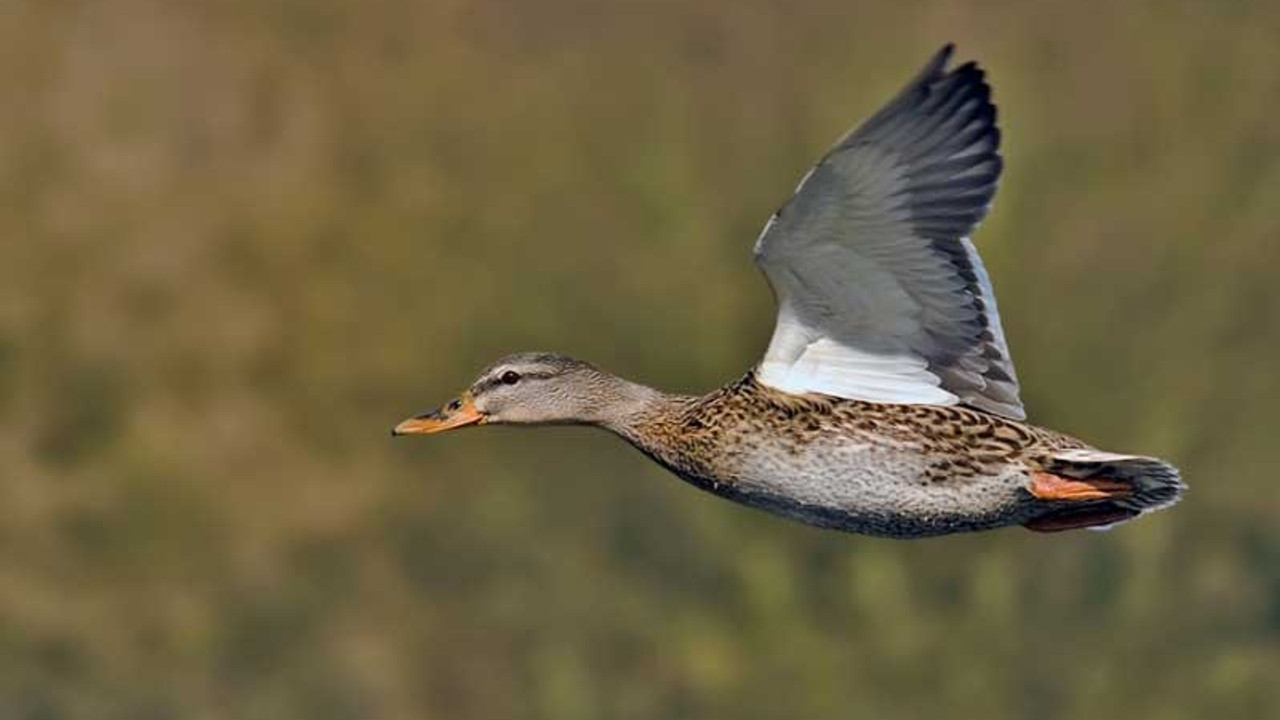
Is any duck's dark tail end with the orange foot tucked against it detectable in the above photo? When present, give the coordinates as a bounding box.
[1027,448,1187,532]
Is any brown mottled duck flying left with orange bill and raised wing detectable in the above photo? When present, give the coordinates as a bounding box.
[392,45,1184,538]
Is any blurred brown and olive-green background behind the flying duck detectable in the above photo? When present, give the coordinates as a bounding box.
[0,0,1280,720]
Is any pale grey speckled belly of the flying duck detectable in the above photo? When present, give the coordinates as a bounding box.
[680,438,1036,538]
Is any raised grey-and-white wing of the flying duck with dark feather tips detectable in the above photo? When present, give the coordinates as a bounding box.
[755,45,1025,419]
